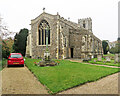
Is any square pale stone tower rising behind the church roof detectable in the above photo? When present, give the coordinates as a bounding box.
[78,17,92,32]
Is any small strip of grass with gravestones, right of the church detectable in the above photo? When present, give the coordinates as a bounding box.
[88,58,120,67]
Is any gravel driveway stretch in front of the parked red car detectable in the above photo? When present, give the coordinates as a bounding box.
[2,67,48,94]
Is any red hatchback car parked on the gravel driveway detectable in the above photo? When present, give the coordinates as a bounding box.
[7,53,24,67]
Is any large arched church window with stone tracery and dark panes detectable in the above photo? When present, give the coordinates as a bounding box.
[38,20,50,45]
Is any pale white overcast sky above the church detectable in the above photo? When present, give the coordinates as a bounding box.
[0,0,119,41]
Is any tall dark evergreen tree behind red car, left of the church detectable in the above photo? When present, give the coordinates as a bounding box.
[13,28,28,56]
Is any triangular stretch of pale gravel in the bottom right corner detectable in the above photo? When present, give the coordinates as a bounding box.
[59,73,120,94]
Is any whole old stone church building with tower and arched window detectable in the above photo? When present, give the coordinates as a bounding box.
[26,12,103,59]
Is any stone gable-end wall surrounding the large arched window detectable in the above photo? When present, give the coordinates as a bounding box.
[31,14,57,58]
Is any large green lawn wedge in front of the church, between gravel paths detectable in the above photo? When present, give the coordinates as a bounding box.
[25,58,118,94]
